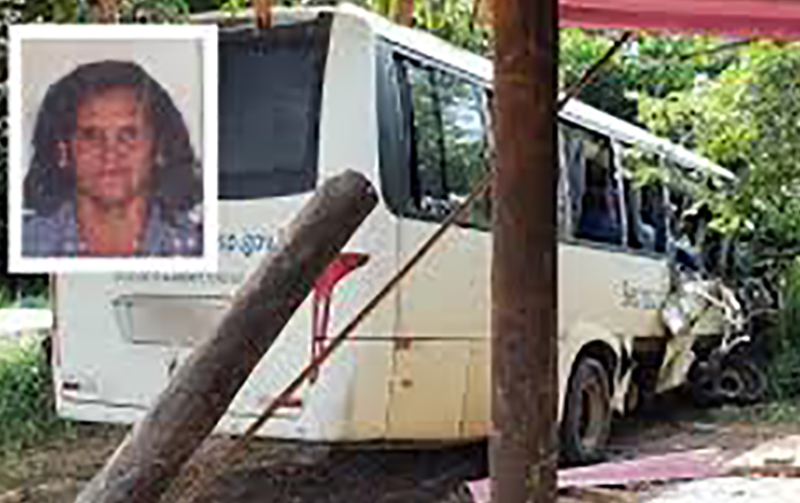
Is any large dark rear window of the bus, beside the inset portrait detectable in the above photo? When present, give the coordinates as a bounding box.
[219,16,330,199]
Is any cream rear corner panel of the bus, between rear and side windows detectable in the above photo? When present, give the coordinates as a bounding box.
[286,9,397,441]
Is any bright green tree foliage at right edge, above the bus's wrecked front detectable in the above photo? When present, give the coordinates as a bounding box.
[640,42,800,247]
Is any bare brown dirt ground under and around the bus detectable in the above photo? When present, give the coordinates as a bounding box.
[0,398,800,503]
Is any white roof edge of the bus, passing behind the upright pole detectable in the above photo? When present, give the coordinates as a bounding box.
[192,3,736,181]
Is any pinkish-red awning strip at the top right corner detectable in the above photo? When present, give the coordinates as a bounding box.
[559,0,800,38]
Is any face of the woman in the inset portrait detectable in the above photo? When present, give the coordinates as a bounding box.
[73,86,154,206]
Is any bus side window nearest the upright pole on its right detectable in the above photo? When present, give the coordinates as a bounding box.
[577,133,622,244]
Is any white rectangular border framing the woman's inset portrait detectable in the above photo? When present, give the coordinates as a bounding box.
[7,24,219,273]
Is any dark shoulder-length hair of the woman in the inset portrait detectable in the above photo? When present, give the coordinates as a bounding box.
[24,61,203,221]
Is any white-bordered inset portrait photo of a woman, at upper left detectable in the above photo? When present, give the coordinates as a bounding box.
[8,25,217,273]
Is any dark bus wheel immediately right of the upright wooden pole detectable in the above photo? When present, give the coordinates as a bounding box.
[561,357,612,464]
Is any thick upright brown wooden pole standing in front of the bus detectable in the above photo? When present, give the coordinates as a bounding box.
[490,0,558,503]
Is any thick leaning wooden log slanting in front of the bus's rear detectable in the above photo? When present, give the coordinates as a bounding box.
[76,172,377,503]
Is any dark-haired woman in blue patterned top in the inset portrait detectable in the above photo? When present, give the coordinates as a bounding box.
[22,61,202,257]
